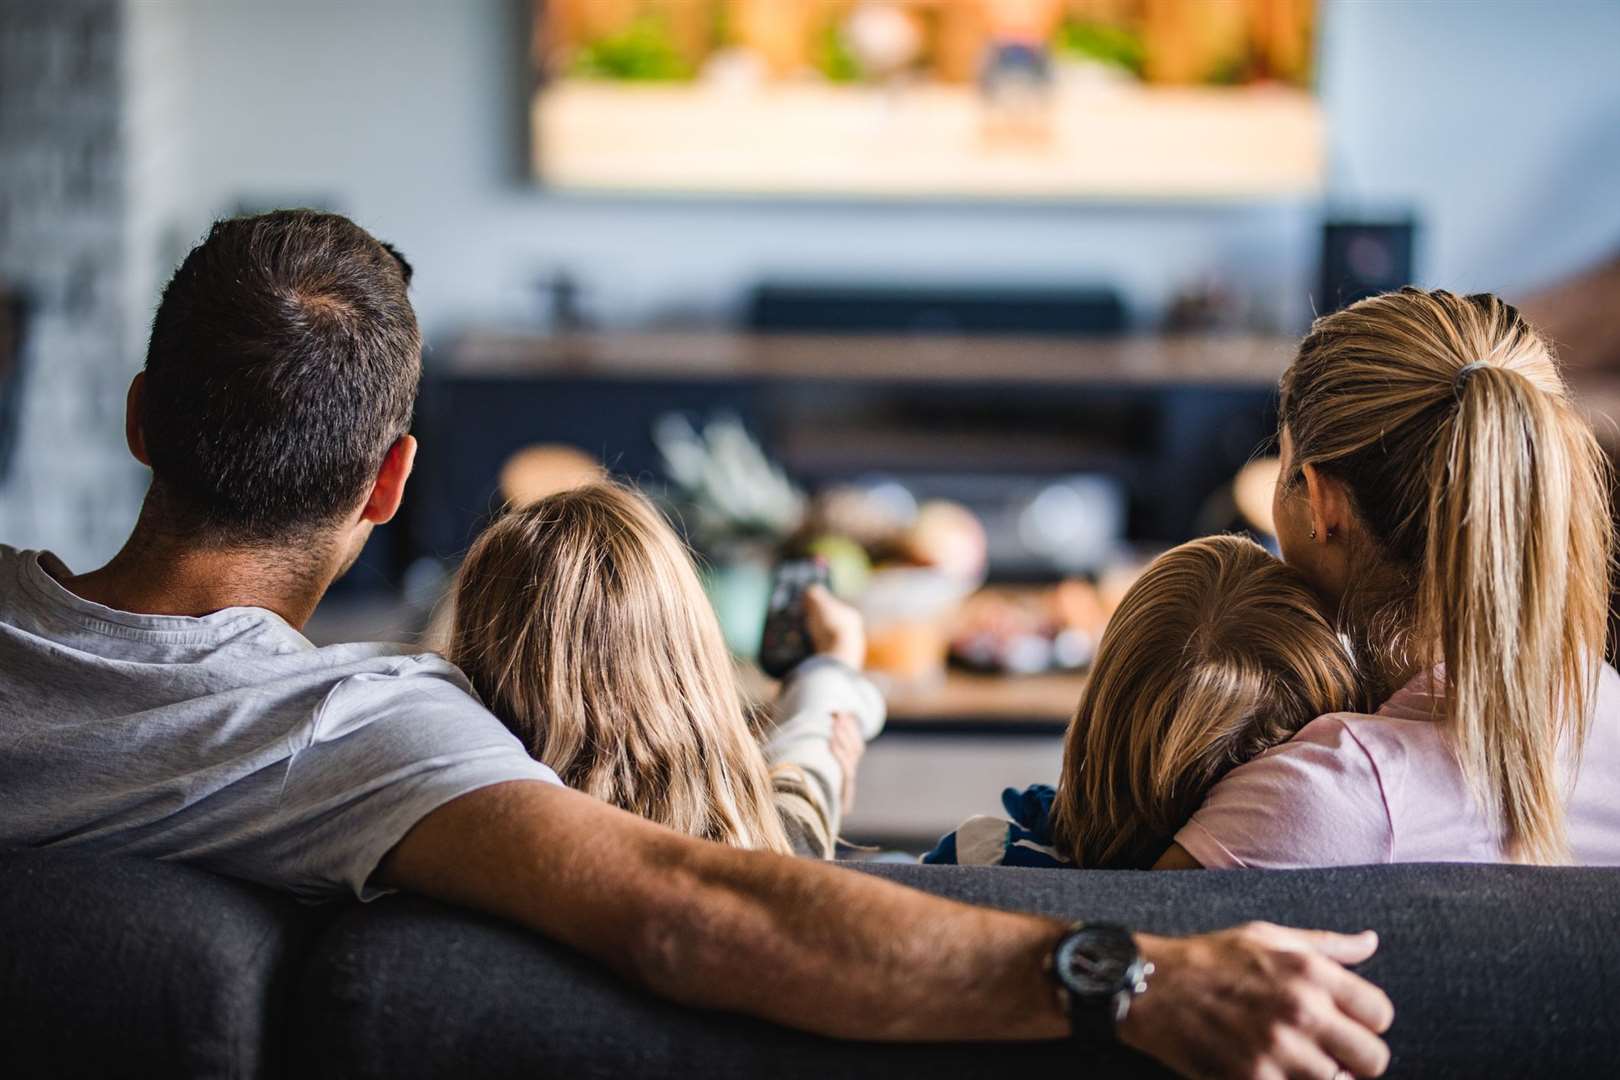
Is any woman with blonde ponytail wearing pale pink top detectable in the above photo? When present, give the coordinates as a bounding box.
[1158,288,1620,868]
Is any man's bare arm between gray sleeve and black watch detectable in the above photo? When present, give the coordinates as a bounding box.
[379,782,1066,1040]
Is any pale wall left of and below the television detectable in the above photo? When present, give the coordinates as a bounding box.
[161,0,1309,341]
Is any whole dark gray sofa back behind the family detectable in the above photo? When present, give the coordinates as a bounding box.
[0,852,1620,1080]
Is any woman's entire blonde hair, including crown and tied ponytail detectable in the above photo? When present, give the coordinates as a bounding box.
[1281,288,1614,863]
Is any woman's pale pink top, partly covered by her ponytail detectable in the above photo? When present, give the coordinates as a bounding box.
[1176,664,1620,870]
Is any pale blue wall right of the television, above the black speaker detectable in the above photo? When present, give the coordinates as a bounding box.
[1322,0,1620,293]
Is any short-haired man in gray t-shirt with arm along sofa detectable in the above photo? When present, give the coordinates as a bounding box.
[0,210,1392,1078]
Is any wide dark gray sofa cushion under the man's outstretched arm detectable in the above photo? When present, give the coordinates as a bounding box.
[300,865,1620,1078]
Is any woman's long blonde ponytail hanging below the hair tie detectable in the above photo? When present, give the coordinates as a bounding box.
[1418,364,1605,863]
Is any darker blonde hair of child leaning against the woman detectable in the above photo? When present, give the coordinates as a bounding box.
[1053,536,1361,868]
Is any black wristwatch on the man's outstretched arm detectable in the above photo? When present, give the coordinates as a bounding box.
[1047,923,1153,1044]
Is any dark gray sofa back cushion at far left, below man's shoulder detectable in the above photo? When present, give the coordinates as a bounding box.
[0,850,322,1078]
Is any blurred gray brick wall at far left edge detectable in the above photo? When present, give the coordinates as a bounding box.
[0,0,156,568]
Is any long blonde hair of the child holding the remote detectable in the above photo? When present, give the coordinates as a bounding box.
[447,484,802,853]
